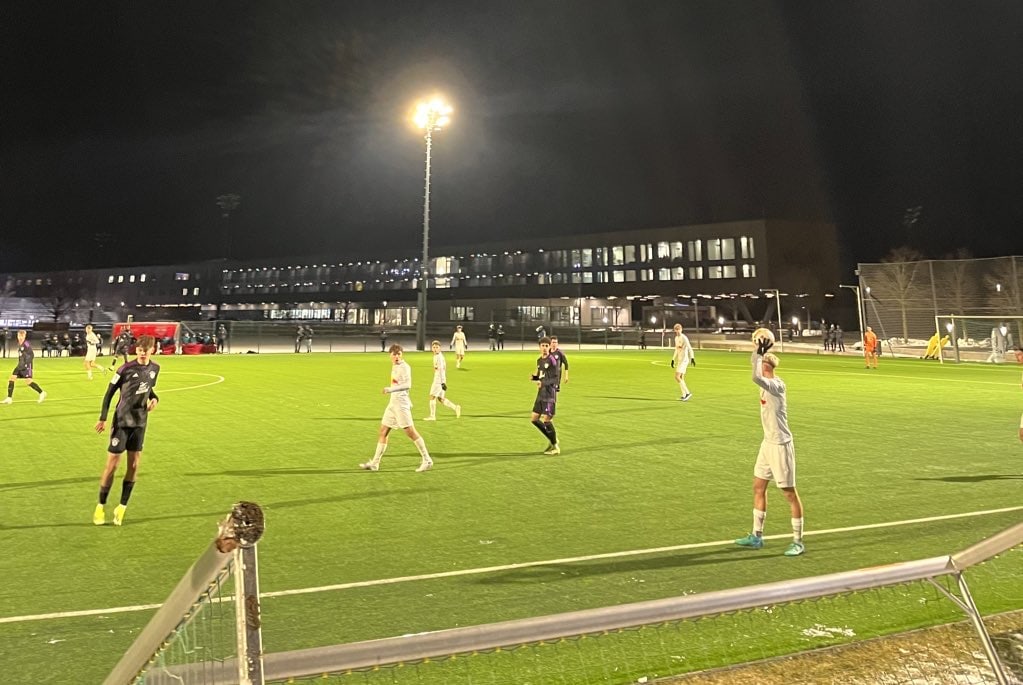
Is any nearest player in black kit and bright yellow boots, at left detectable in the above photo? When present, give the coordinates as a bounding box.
[92,335,160,526]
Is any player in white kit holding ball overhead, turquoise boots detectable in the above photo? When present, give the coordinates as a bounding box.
[736,338,806,556]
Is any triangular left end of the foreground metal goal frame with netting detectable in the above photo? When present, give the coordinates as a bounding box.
[103,502,263,685]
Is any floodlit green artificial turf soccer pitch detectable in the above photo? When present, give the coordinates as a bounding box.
[0,349,1023,683]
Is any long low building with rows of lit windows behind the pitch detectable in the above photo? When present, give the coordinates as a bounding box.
[0,220,839,327]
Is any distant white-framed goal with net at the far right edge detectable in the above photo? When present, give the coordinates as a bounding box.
[928,314,1023,364]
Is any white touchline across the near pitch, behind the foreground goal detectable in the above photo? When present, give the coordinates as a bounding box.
[0,506,1023,624]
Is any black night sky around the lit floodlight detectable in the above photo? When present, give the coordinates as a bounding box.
[0,0,1023,275]
